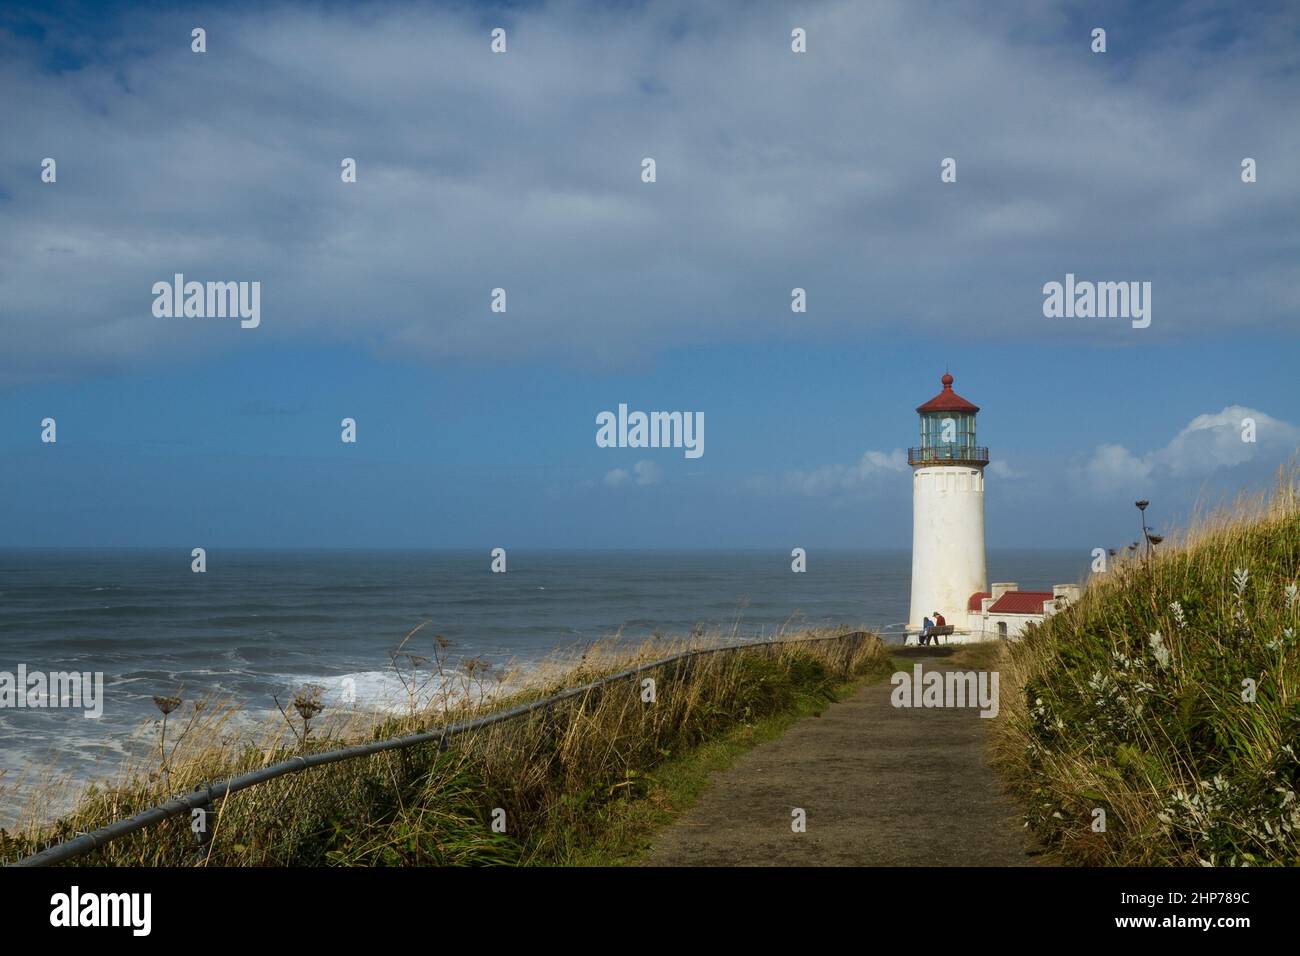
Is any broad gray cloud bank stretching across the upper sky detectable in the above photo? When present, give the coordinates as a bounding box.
[0,1,1300,384]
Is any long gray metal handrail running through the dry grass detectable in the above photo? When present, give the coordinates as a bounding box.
[9,631,868,866]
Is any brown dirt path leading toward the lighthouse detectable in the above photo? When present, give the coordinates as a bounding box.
[642,648,1036,866]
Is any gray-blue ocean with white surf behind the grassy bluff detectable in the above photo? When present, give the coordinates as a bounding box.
[0,549,1091,819]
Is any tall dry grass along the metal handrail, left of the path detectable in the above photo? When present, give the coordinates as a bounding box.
[0,630,888,866]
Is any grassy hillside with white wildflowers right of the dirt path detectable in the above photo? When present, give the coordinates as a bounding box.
[997,472,1300,865]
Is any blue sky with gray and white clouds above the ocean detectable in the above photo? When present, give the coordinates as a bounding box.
[0,1,1300,550]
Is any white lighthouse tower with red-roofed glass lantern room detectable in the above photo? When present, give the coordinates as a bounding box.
[907,372,988,640]
